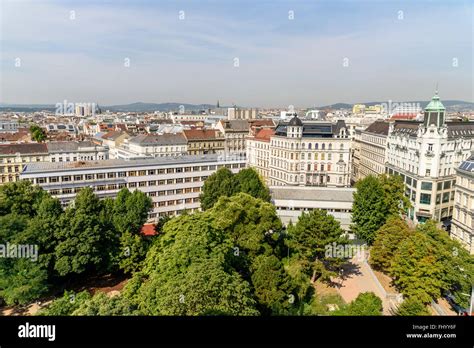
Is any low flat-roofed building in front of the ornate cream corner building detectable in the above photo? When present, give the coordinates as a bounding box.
[270,186,355,231]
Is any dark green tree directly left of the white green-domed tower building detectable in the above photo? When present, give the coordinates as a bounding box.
[351,175,410,245]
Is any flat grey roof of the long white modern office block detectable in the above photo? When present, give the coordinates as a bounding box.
[21,154,245,174]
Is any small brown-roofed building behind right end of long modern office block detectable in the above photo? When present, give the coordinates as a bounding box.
[183,128,225,155]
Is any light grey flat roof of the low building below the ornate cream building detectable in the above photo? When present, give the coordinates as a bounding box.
[270,186,355,202]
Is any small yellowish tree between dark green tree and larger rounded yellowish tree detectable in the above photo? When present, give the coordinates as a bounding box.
[369,216,410,272]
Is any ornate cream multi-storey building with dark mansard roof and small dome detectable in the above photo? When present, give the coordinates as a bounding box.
[269,113,351,187]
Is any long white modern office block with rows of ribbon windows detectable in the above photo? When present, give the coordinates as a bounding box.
[20,155,246,219]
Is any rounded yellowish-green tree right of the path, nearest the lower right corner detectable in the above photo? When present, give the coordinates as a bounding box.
[390,231,448,304]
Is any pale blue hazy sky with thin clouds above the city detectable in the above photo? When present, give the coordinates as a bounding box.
[0,0,474,107]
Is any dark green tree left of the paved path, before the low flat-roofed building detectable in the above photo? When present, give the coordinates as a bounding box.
[288,209,348,282]
